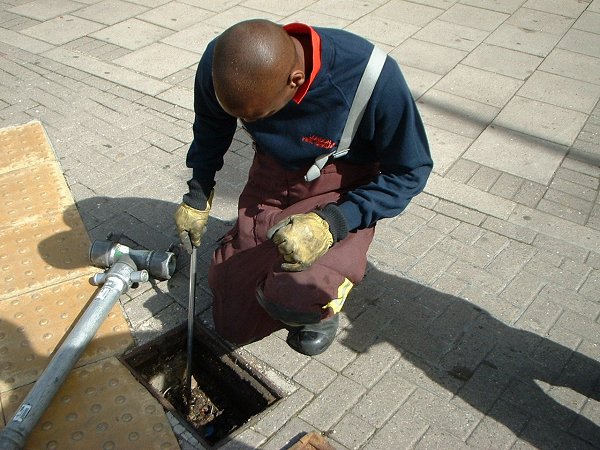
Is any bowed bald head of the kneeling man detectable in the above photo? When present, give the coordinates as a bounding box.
[213,20,304,120]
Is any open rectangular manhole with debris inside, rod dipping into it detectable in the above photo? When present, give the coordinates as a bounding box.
[121,323,283,447]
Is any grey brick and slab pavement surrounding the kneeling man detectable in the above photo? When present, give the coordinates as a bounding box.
[0,0,600,449]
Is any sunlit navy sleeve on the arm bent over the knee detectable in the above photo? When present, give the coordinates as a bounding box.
[338,57,433,231]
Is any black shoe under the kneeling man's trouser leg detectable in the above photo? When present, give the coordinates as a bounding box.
[286,314,340,356]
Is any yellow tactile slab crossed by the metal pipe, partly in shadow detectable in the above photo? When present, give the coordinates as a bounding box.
[0,277,133,392]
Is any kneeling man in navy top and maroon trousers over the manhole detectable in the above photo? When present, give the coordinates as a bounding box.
[175,20,432,355]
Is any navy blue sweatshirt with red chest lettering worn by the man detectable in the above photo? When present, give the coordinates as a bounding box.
[187,28,433,231]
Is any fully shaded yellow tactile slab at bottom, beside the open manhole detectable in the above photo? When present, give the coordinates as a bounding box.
[0,357,179,450]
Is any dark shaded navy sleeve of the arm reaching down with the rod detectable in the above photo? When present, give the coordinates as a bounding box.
[184,42,237,207]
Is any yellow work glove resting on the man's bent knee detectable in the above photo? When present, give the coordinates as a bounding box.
[267,212,333,272]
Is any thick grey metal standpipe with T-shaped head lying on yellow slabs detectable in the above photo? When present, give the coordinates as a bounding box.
[0,241,175,450]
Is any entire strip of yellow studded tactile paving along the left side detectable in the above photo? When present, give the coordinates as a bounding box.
[0,122,179,450]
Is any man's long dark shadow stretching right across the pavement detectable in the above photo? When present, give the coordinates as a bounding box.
[339,263,600,449]
